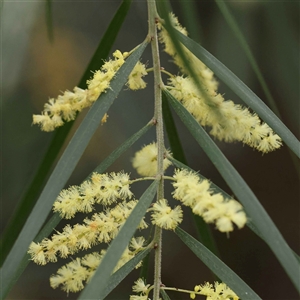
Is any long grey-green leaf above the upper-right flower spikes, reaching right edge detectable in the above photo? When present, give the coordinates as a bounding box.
[176,31,300,158]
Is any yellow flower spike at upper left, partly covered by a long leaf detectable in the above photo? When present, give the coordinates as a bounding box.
[33,50,147,131]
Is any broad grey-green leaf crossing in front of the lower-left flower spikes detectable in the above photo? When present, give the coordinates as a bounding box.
[78,181,158,300]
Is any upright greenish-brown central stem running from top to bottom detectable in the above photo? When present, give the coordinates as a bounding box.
[147,0,165,300]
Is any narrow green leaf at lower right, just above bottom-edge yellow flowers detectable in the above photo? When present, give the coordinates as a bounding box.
[175,227,261,300]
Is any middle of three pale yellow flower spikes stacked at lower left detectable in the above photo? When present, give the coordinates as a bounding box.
[28,200,147,265]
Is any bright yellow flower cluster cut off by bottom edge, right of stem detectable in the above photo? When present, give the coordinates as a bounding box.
[190,282,239,300]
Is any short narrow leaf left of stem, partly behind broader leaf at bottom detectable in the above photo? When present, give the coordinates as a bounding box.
[103,248,152,298]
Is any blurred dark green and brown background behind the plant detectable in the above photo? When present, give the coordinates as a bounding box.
[1,0,300,300]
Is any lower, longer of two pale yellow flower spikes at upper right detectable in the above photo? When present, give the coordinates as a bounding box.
[169,76,281,153]
